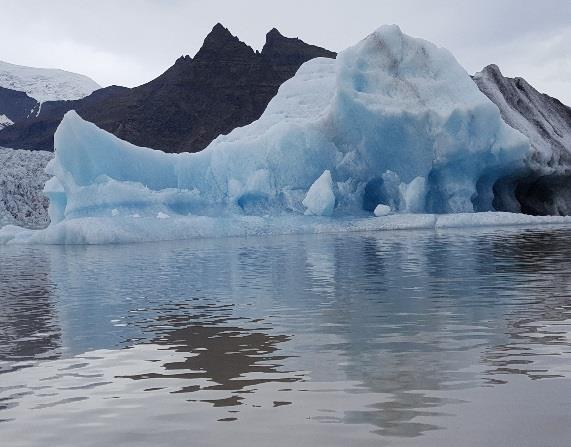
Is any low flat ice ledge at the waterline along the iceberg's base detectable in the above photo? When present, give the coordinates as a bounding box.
[0,213,571,244]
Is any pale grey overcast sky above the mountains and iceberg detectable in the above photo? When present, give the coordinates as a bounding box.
[0,0,571,105]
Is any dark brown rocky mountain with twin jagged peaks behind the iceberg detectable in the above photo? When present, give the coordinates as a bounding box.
[0,24,336,152]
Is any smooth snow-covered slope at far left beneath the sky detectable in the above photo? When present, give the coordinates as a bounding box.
[0,61,101,103]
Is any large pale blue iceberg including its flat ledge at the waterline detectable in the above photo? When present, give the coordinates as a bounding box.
[0,25,569,243]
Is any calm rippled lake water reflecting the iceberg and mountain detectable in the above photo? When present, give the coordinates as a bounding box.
[0,228,571,447]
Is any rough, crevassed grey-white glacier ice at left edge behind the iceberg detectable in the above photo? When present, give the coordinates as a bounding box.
[0,148,53,228]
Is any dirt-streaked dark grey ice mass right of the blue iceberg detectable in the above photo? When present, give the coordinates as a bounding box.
[474,65,571,215]
